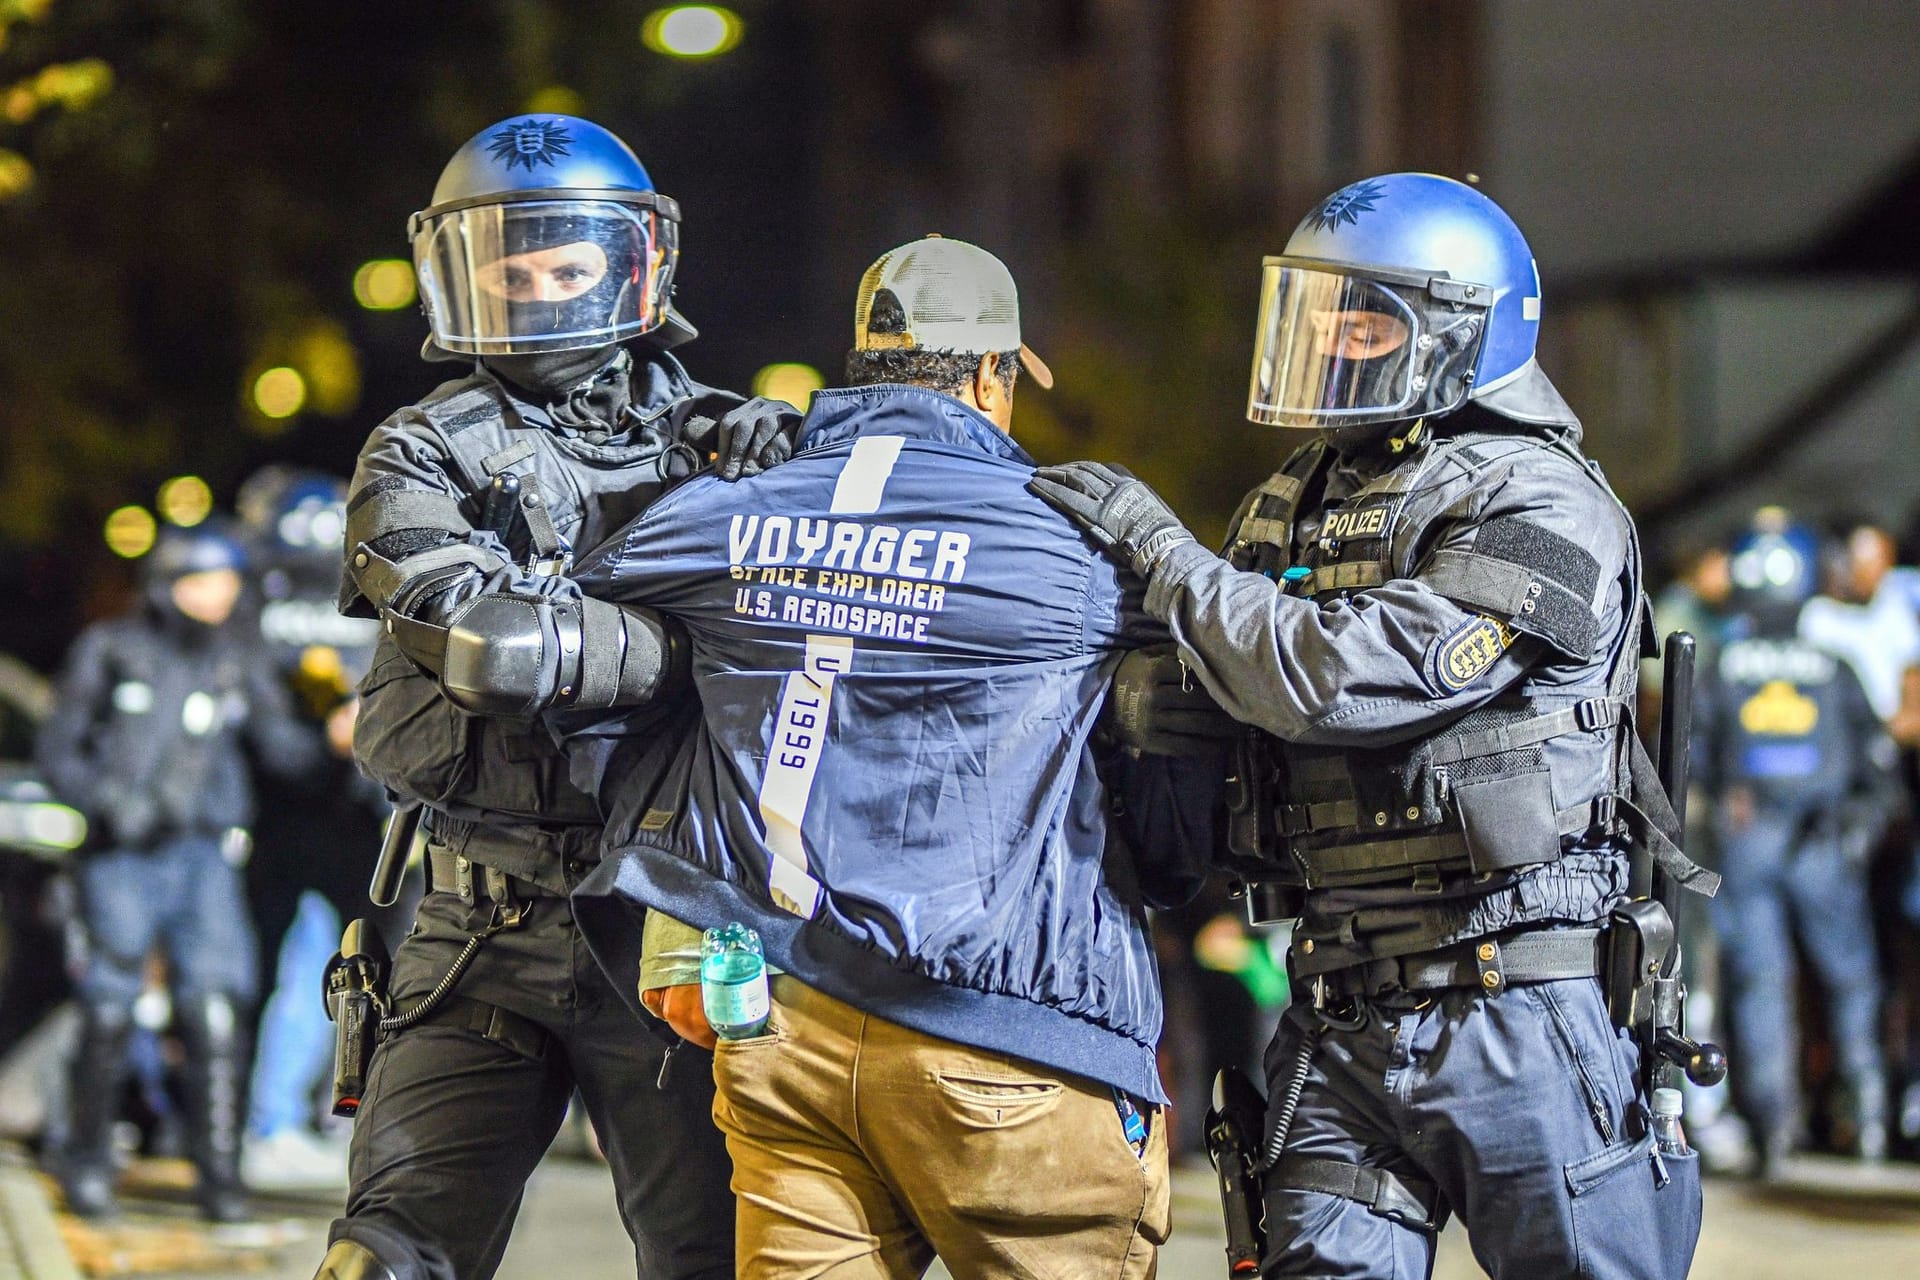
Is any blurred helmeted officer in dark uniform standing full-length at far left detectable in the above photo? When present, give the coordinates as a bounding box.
[36,520,313,1221]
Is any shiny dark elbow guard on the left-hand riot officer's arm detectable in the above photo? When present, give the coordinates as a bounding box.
[440,595,689,720]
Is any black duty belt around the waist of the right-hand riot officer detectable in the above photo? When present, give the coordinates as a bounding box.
[1288,929,1607,1004]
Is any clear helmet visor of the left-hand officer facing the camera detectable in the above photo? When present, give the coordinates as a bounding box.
[413,200,680,355]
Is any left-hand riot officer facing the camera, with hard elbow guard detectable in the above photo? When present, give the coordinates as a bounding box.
[321,115,797,1280]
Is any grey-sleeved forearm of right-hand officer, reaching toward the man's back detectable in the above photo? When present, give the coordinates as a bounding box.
[1146,545,1536,747]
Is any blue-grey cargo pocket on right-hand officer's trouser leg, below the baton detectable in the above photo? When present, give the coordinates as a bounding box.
[1565,1134,1701,1280]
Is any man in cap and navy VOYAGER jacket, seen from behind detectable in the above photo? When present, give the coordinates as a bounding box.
[560,238,1204,1280]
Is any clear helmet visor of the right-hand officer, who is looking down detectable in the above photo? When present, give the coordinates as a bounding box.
[1246,259,1484,428]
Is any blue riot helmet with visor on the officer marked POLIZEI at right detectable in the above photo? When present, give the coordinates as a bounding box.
[1246,173,1574,432]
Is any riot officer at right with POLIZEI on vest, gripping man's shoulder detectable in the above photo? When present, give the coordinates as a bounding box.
[1035,173,1699,1278]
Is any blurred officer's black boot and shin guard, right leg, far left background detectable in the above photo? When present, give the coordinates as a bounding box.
[175,996,252,1222]
